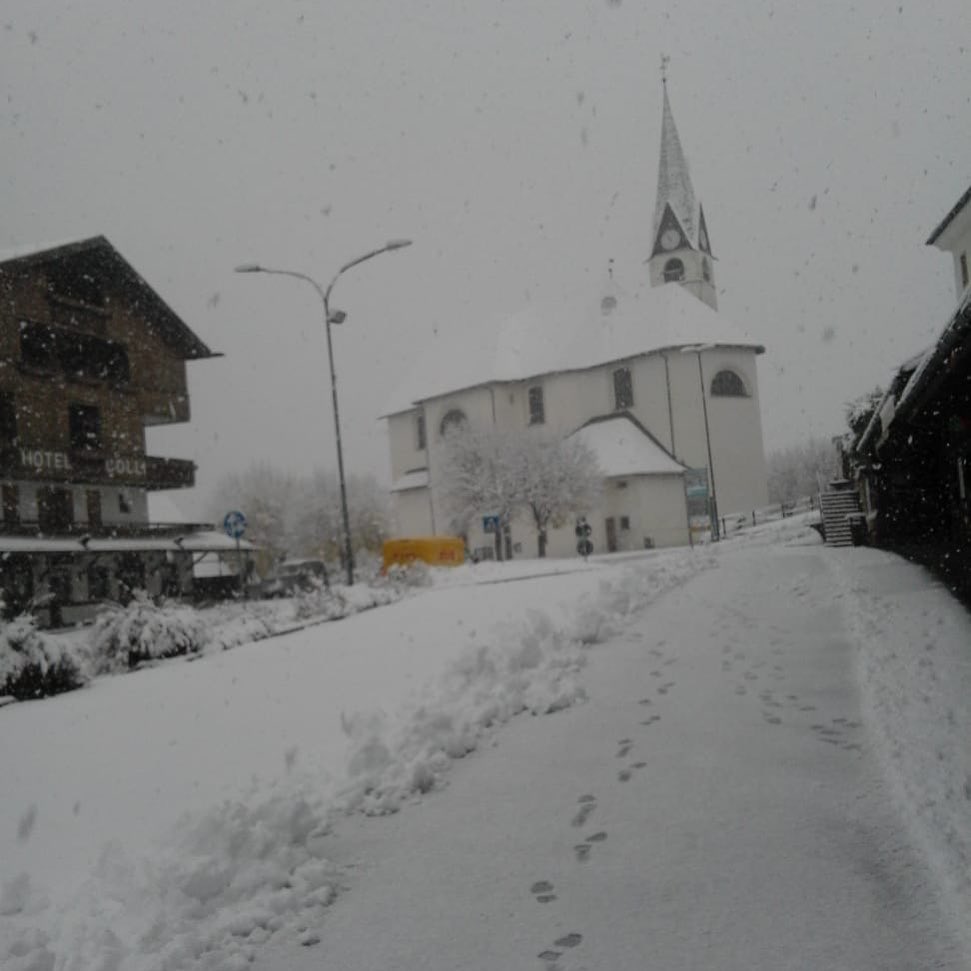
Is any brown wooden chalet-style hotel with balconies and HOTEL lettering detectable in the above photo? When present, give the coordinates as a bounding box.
[0,236,243,626]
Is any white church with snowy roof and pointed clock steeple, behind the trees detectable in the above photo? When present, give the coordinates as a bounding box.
[382,79,768,556]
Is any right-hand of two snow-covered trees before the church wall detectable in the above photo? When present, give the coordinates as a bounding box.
[515,431,603,556]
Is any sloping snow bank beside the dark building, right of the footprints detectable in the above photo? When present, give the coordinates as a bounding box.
[831,547,971,951]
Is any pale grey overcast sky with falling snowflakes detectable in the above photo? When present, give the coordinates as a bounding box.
[0,0,971,512]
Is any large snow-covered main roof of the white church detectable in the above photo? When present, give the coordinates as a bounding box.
[382,283,765,417]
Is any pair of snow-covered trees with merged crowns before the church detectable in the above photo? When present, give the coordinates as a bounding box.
[437,423,601,556]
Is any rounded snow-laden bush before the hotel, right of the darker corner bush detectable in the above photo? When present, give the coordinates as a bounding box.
[90,593,208,674]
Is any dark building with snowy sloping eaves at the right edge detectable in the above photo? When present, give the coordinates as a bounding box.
[853,180,971,597]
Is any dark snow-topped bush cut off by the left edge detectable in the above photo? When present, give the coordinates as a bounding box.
[0,614,85,700]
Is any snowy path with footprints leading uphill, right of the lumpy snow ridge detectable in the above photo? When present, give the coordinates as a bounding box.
[255,546,971,971]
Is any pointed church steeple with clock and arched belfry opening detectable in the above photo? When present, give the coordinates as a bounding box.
[648,57,718,310]
